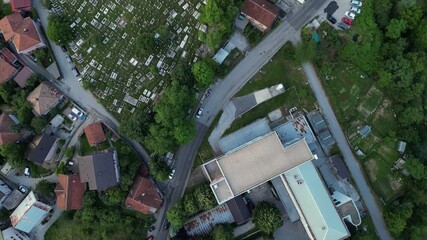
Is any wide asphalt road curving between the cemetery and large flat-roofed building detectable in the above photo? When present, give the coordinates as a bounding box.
[152,0,332,239]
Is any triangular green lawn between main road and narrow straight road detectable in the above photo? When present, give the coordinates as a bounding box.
[224,43,316,135]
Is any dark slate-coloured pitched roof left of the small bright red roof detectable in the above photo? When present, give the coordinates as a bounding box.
[28,134,58,164]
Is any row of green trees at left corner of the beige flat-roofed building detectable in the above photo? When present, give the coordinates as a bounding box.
[167,184,217,228]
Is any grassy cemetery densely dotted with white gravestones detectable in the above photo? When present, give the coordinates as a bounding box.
[54,0,204,119]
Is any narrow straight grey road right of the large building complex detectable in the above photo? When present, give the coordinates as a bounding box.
[303,63,392,240]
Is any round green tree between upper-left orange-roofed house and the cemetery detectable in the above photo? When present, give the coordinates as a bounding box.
[47,14,73,45]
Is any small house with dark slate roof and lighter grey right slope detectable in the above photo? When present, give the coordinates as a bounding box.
[28,134,59,165]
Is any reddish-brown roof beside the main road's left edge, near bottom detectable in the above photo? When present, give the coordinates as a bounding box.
[125,175,163,214]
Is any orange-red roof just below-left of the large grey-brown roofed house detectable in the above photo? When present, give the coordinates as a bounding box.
[55,174,86,210]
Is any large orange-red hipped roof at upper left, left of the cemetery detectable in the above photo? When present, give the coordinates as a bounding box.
[0,13,41,52]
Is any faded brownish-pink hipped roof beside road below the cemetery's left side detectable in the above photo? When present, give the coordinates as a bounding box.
[27,82,63,116]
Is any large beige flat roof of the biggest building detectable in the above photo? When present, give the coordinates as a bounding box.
[203,132,314,204]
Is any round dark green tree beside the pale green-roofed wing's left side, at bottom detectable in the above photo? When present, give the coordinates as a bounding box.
[253,202,283,234]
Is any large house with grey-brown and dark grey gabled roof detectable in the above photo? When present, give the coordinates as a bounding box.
[78,149,120,191]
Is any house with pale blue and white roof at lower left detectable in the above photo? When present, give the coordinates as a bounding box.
[10,191,52,233]
